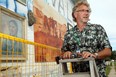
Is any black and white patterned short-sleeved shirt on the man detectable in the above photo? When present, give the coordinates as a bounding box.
[61,23,112,77]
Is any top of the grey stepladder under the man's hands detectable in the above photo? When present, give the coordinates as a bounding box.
[59,57,99,77]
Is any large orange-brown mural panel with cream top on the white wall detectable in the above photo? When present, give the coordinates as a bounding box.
[33,0,67,62]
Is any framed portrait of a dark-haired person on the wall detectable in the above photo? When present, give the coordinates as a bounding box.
[0,7,25,60]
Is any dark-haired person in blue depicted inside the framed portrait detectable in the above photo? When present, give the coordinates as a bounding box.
[2,20,22,55]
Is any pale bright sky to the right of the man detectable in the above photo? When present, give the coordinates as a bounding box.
[88,0,116,50]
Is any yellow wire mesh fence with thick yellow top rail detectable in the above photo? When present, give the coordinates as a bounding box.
[0,33,61,77]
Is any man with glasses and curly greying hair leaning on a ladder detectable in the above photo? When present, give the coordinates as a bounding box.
[61,0,112,77]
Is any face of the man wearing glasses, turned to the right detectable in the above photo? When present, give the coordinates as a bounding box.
[74,5,90,23]
